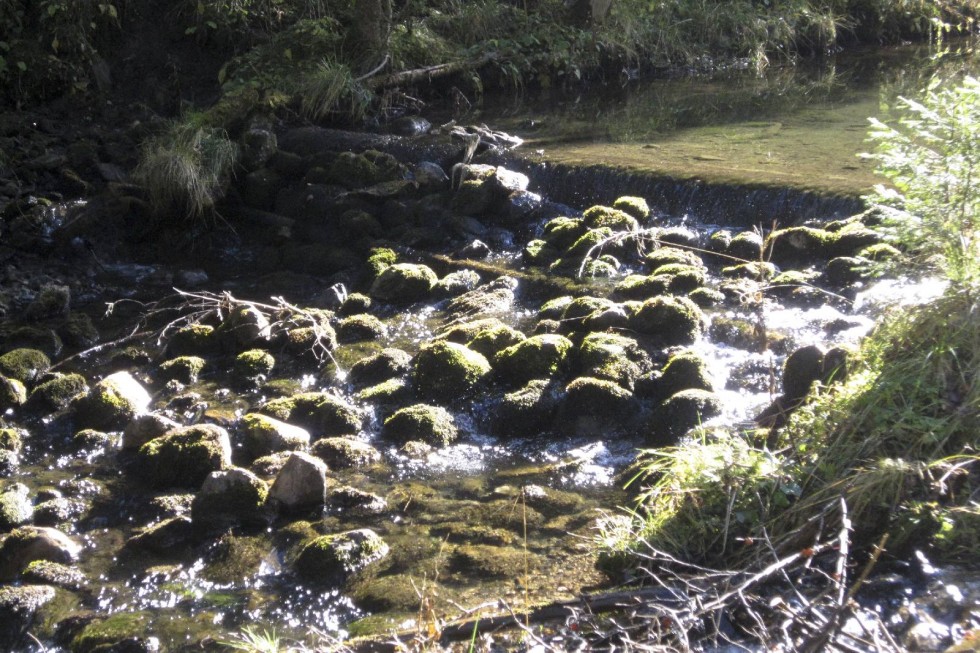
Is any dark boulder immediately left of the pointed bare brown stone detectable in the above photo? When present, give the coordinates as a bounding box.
[191,467,272,531]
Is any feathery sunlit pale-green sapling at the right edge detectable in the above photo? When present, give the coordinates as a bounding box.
[869,77,980,285]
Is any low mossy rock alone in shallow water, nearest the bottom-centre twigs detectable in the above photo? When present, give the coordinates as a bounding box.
[294,528,389,586]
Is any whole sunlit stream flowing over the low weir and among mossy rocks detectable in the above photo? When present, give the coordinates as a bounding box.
[0,40,977,652]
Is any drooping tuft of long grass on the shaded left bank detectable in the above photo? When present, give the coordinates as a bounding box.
[135,120,238,221]
